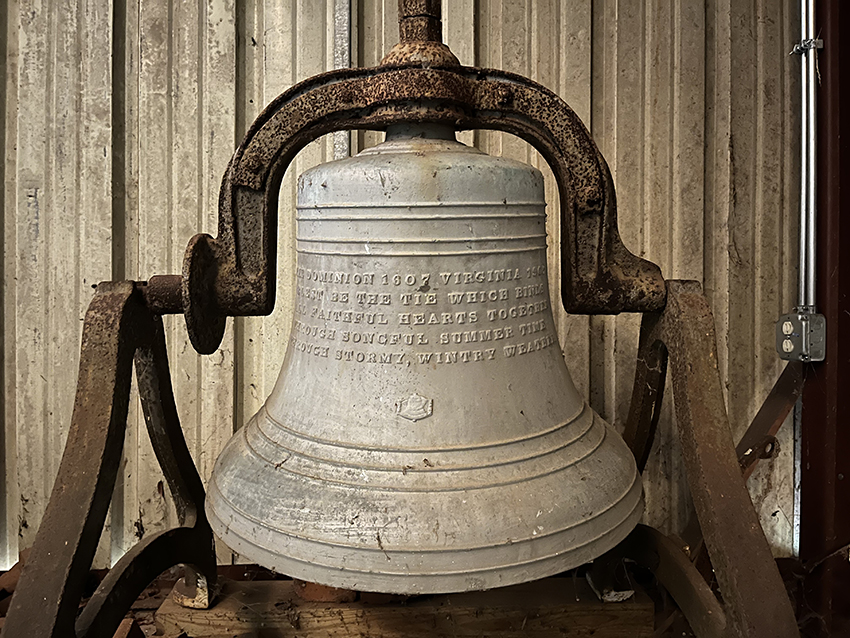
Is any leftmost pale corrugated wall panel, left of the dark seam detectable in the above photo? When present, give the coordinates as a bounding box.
[2,1,112,562]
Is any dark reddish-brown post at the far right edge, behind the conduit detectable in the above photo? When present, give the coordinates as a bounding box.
[800,0,850,636]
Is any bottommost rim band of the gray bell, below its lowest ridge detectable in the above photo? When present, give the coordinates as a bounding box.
[205,490,644,595]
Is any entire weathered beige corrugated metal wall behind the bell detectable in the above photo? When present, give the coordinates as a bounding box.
[0,0,798,568]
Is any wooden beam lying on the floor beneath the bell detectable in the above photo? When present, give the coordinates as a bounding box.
[156,578,654,638]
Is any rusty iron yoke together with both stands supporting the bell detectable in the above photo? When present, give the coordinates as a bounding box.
[3,5,799,638]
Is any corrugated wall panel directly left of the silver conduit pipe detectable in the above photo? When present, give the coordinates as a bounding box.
[705,0,800,554]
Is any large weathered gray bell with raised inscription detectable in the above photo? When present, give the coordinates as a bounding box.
[206,127,643,593]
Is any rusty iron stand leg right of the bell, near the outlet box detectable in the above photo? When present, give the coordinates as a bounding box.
[623,281,800,638]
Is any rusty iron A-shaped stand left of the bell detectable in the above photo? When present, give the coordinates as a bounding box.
[3,281,216,638]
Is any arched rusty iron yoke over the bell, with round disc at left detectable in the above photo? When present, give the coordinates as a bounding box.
[182,66,665,353]
